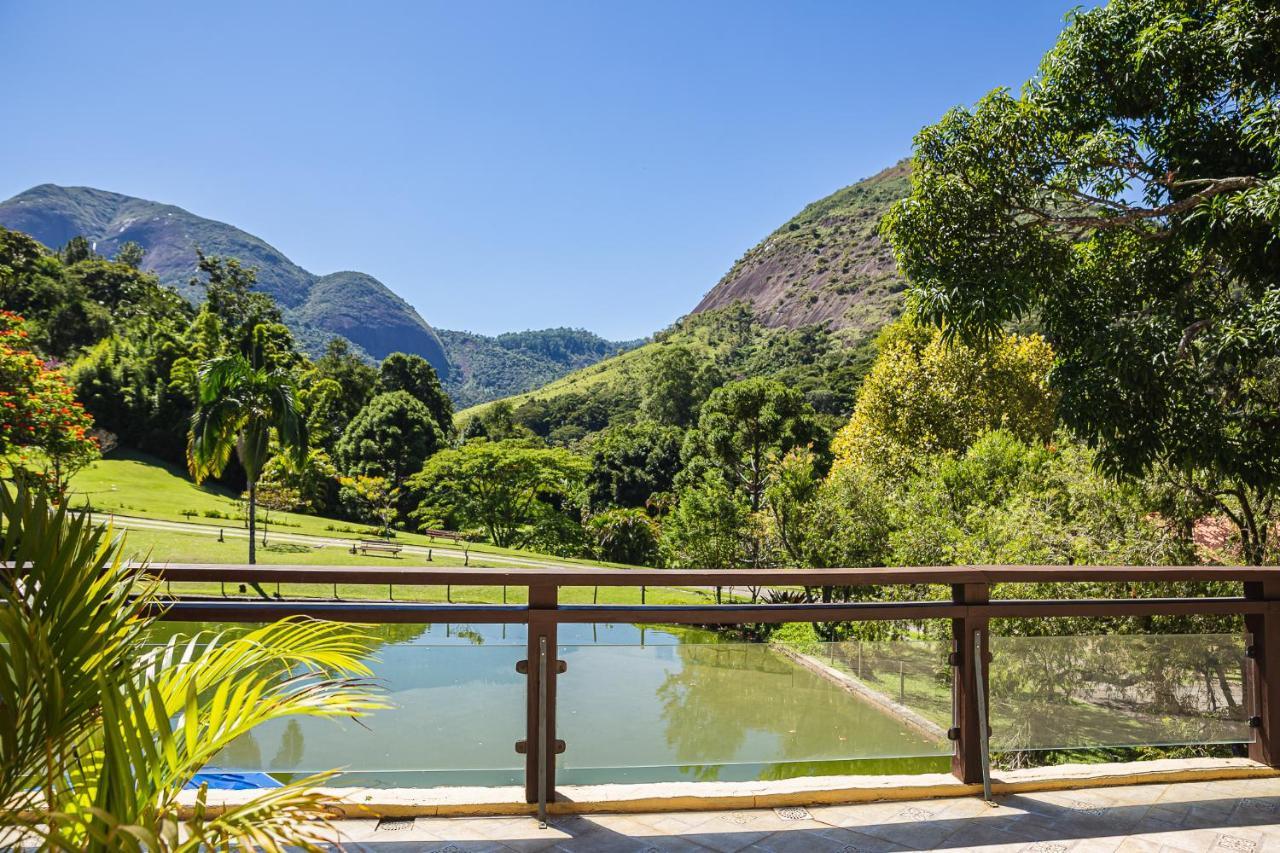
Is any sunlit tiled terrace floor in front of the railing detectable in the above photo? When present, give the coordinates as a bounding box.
[325,779,1280,853]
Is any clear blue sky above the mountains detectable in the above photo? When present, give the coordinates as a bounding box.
[0,0,1074,338]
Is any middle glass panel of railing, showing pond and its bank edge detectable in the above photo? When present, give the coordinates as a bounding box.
[557,628,951,784]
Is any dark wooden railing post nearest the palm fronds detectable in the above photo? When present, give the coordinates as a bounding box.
[525,585,561,803]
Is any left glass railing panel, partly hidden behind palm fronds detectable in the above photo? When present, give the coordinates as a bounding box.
[151,624,526,788]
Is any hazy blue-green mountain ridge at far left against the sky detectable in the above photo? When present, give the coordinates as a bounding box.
[0,183,449,377]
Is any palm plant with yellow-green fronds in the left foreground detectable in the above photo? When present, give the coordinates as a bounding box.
[0,473,383,853]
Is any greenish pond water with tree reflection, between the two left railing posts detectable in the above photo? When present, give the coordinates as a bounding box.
[558,643,951,783]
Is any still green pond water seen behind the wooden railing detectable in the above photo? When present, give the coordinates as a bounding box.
[160,625,951,786]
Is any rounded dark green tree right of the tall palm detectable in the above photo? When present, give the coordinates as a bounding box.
[334,391,444,487]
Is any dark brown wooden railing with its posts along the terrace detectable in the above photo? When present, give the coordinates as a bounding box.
[145,565,1280,808]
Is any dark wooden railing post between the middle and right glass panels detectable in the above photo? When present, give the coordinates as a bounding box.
[951,584,991,785]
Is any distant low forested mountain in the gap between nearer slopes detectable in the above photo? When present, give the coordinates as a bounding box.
[436,328,644,409]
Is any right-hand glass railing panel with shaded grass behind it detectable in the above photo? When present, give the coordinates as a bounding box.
[991,634,1252,752]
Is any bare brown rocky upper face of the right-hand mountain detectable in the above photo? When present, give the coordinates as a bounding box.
[694,160,910,333]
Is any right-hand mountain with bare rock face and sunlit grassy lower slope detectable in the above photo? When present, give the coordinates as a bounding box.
[457,160,910,434]
